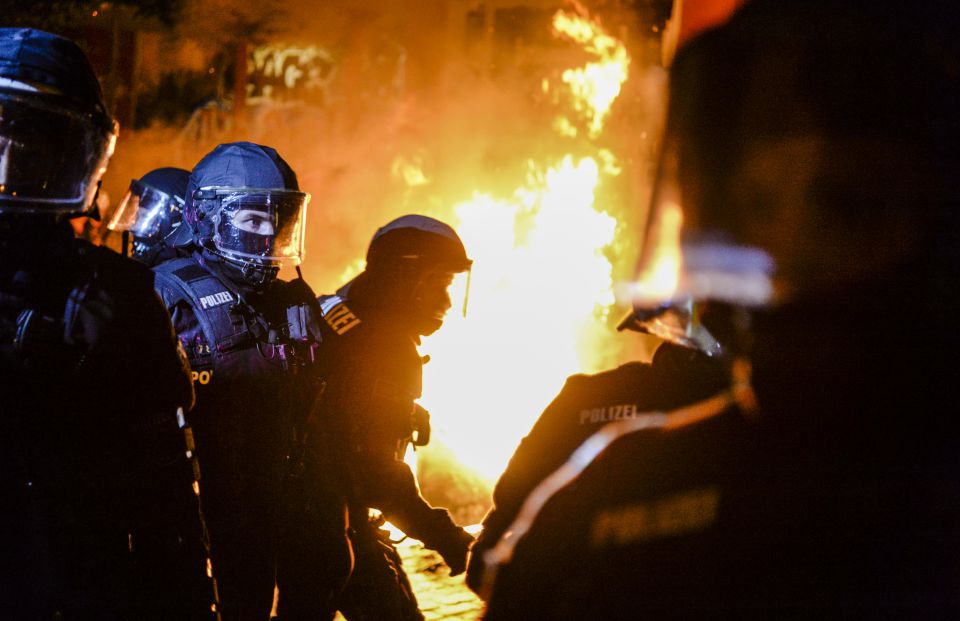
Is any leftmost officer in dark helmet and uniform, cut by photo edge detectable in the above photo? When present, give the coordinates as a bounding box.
[0,28,213,620]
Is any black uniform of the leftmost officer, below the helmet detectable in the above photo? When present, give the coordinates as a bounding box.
[0,225,213,620]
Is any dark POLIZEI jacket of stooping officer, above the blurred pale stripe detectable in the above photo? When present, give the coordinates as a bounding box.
[467,343,726,593]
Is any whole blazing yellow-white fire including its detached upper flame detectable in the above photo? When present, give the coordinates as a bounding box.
[414,11,630,480]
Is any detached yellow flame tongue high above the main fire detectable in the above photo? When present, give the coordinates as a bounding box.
[553,11,630,138]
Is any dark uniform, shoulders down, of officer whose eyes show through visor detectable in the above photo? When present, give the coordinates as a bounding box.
[154,253,318,619]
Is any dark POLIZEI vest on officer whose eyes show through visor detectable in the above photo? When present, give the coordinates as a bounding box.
[154,257,320,386]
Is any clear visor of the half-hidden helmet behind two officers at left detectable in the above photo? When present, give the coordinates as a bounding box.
[107,180,183,243]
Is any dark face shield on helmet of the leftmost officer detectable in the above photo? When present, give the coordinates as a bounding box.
[0,88,117,213]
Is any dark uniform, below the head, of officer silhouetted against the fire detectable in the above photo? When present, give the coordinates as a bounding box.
[294,276,466,619]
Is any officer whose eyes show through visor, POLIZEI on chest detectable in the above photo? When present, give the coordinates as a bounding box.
[154,142,319,621]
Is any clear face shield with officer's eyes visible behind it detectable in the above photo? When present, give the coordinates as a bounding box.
[193,187,310,267]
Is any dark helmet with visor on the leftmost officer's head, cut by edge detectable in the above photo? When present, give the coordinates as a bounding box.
[0,28,118,215]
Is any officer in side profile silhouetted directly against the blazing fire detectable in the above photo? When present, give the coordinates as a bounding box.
[279,215,473,620]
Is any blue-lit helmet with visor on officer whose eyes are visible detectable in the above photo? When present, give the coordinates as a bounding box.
[184,142,310,286]
